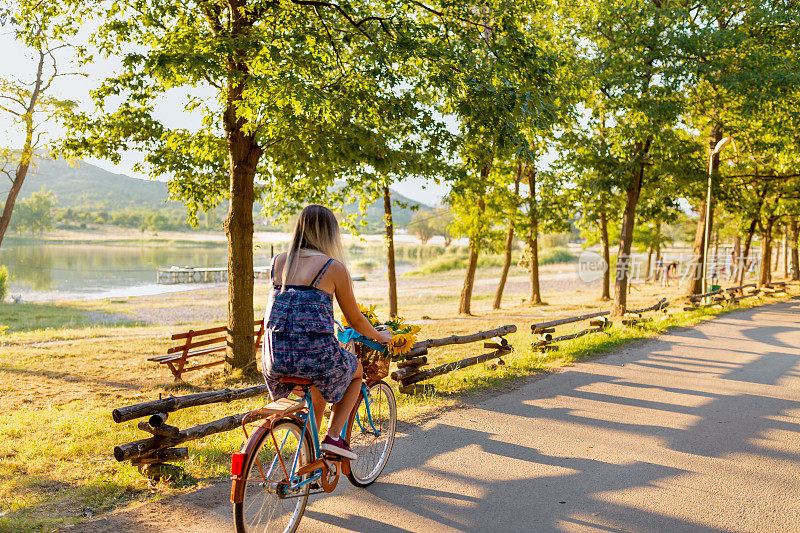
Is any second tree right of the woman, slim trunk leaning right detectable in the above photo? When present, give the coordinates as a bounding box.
[434,2,554,314]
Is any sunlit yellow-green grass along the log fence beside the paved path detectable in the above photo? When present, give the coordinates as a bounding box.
[0,269,792,531]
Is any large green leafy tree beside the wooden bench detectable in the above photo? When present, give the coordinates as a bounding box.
[69,0,462,370]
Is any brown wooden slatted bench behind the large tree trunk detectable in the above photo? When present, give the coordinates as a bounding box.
[147,319,264,381]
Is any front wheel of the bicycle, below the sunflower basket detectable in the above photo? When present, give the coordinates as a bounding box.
[347,381,397,487]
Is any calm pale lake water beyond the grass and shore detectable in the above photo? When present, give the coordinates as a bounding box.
[0,242,413,301]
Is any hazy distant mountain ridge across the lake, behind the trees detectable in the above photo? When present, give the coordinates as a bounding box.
[14,154,431,230]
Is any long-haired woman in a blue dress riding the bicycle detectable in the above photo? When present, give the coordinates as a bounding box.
[263,205,391,460]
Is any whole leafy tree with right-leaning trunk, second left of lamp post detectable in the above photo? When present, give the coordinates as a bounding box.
[564,0,685,315]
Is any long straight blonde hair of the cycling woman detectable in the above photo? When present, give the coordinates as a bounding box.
[281,204,344,291]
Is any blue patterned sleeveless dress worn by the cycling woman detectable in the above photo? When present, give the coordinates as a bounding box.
[263,259,358,403]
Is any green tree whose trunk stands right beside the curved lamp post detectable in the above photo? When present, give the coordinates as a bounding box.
[678,0,800,294]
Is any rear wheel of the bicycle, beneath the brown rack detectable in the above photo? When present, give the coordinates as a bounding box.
[233,420,313,533]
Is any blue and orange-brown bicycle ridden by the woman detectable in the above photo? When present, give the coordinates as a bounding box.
[231,338,397,533]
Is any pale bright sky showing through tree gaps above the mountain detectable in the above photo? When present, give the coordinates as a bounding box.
[0,28,448,206]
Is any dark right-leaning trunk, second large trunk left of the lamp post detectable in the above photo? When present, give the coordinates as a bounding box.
[613,139,652,316]
